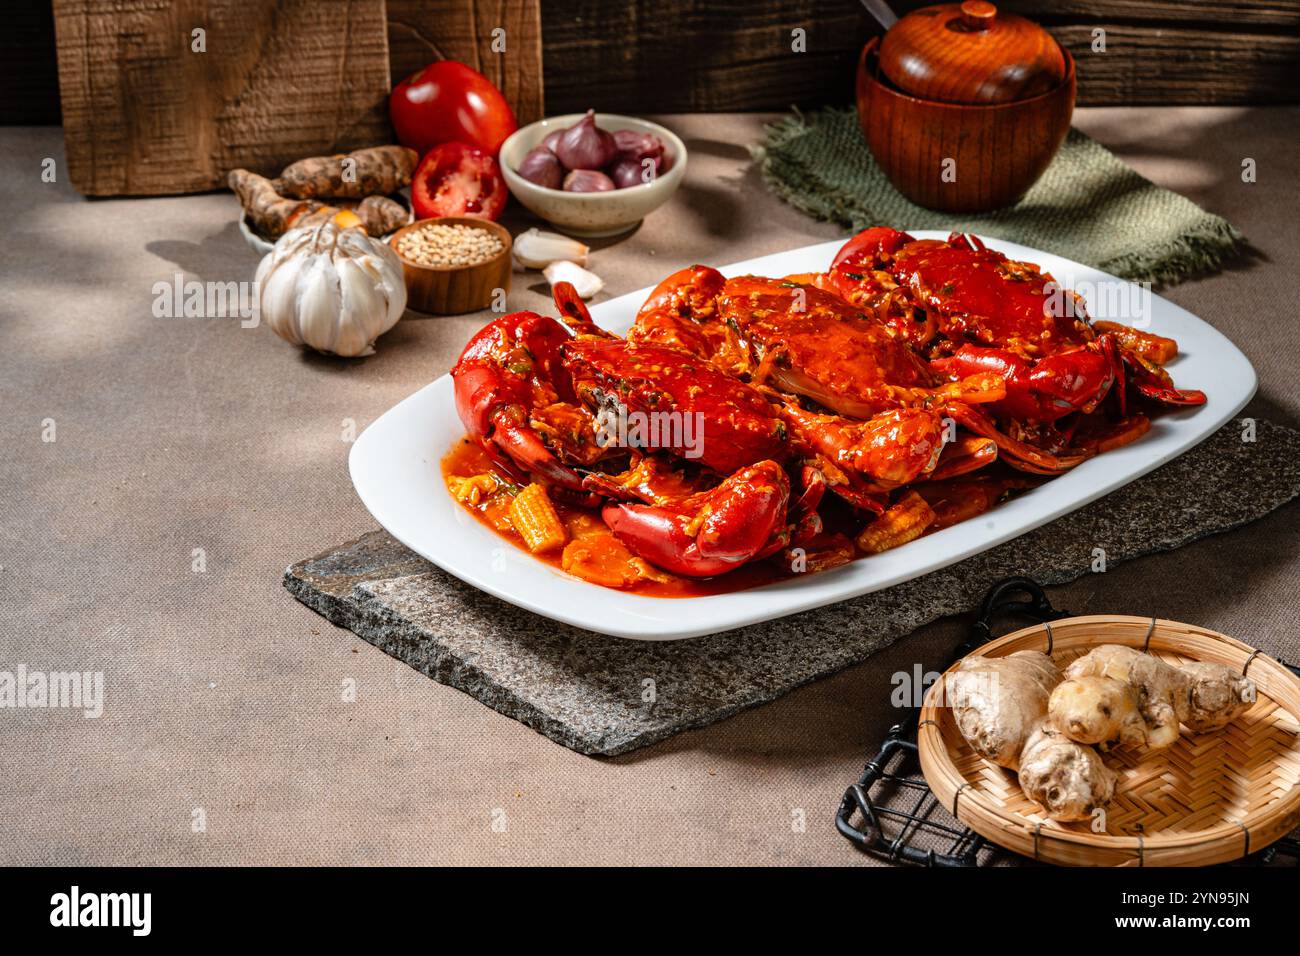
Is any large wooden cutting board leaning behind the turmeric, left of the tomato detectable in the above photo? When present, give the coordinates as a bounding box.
[55,0,391,195]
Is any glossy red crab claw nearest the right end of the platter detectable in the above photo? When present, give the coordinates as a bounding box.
[931,345,1115,423]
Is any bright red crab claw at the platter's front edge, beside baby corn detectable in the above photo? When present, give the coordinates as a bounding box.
[601,460,790,578]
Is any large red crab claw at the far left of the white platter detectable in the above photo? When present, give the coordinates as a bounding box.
[451,312,582,492]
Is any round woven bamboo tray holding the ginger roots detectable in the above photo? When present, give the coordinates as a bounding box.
[917,615,1300,866]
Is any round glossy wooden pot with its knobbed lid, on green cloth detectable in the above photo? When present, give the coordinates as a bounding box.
[857,0,1075,212]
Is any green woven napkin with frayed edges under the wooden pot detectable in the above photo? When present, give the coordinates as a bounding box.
[753,108,1244,284]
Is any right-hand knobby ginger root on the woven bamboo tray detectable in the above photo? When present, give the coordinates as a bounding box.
[1048,644,1256,749]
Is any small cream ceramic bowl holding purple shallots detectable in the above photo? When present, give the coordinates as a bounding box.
[499,113,686,237]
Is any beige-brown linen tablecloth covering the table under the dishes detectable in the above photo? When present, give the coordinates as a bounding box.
[0,108,1300,864]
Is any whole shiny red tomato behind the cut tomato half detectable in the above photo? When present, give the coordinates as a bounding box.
[389,60,519,156]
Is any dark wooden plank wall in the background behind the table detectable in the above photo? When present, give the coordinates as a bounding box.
[0,0,1300,124]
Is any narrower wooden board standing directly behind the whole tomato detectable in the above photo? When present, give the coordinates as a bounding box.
[387,0,543,126]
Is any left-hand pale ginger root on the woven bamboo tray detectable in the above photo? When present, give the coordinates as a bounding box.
[944,650,1117,821]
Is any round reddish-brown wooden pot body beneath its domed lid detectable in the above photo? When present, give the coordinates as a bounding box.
[857,38,1075,212]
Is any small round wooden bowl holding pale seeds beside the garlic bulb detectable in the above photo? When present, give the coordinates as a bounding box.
[389,216,511,315]
